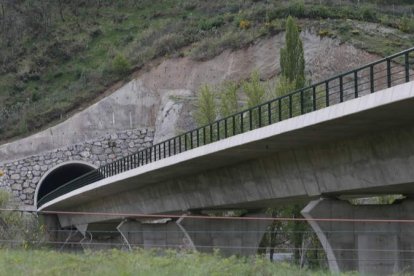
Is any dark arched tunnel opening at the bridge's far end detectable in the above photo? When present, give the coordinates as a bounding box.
[36,163,95,204]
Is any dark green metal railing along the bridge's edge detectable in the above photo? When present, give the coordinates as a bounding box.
[38,48,414,207]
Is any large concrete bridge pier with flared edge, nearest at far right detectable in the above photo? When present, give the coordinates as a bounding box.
[302,199,414,275]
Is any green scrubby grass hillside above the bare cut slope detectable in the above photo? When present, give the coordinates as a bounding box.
[0,0,414,141]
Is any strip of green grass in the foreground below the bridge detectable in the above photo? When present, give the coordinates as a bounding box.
[0,249,350,276]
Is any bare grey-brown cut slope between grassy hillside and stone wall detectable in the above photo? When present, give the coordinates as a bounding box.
[0,30,386,161]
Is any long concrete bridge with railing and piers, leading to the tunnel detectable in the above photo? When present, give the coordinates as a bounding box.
[35,48,414,273]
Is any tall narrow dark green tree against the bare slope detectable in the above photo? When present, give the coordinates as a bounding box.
[280,16,305,89]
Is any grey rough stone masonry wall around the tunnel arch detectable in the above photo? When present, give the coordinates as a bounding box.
[0,129,154,205]
